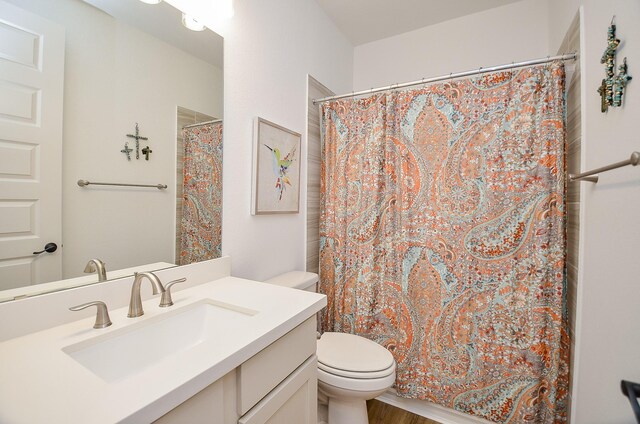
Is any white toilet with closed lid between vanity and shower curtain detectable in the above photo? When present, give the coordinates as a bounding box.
[265,271,396,424]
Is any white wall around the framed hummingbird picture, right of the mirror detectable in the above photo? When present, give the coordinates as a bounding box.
[222,0,353,280]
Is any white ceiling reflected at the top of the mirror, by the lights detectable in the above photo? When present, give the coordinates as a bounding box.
[83,0,223,69]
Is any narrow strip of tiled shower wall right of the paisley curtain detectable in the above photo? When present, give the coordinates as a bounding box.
[558,11,588,418]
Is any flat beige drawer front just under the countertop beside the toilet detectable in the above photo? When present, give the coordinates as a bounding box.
[238,316,316,415]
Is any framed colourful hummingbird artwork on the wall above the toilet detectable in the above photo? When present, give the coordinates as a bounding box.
[251,117,301,215]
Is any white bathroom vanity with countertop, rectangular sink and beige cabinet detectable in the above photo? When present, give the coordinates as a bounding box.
[0,264,327,424]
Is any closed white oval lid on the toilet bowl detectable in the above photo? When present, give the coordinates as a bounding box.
[316,332,394,373]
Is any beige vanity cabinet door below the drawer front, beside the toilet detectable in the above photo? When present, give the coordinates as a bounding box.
[238,355,318,424]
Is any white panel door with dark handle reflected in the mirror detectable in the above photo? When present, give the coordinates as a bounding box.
[0,0,65,290]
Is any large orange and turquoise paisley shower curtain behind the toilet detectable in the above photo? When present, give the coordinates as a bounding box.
[320,63,569,423]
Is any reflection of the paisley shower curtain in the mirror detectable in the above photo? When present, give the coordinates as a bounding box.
[178,121,222,265]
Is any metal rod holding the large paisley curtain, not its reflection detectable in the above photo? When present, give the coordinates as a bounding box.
[313,52,578,105]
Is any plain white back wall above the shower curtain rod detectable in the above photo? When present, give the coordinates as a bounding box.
[353,0,549,90]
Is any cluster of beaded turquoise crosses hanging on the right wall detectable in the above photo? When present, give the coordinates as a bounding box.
[598,16,631,113]
